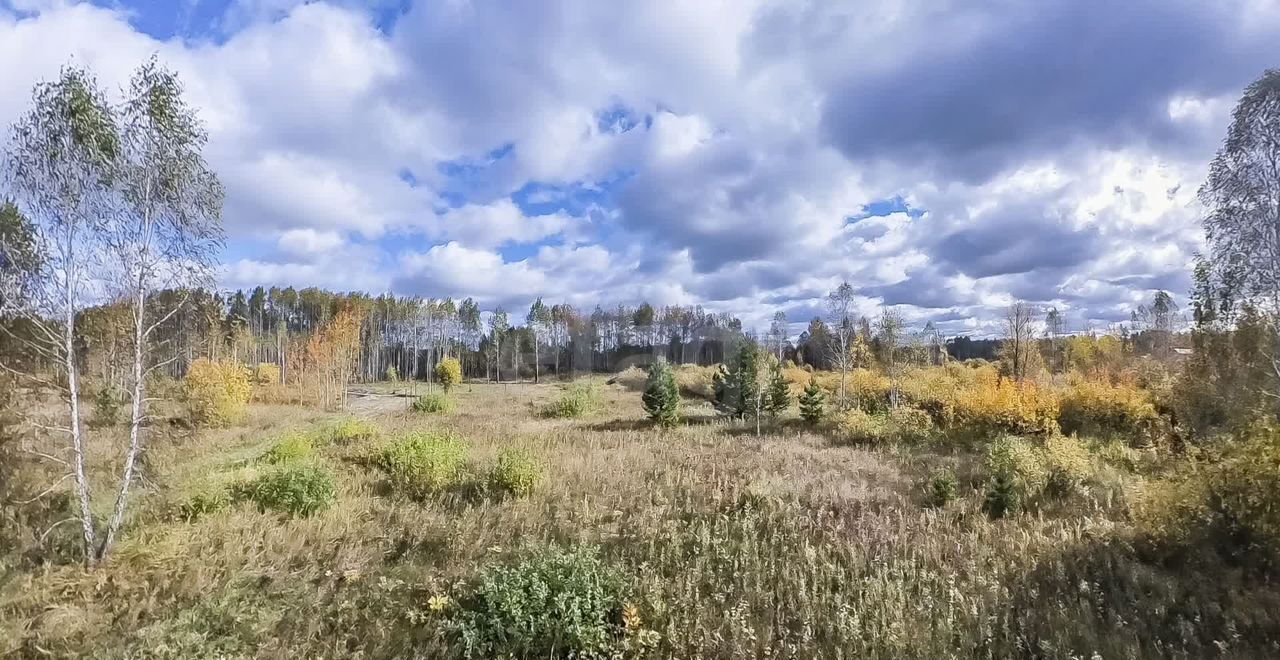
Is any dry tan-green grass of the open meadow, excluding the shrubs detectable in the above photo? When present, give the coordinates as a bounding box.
[0,379,1280,659]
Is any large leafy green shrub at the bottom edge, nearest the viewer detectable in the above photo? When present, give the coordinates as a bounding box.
[445,549,640,657]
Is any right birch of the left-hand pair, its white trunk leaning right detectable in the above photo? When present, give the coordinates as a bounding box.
[97,58,223,558]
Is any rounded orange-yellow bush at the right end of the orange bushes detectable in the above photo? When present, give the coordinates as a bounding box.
[1059,379,1157,436]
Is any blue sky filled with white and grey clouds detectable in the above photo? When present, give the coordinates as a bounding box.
[0,0,1280,335]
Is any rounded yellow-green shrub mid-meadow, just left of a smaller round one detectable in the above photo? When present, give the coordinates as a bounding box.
[375,432,467,498]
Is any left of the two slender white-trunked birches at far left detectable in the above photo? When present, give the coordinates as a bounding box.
[0,67,120,565]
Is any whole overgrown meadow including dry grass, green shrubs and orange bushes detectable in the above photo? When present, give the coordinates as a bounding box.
[0,367,1280,659]
